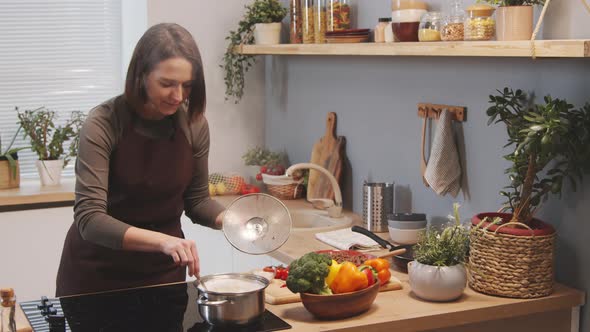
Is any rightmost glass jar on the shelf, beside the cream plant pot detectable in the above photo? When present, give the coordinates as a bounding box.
[463,5,496,40]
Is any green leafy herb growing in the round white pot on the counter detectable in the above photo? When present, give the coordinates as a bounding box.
[414,203,469,266]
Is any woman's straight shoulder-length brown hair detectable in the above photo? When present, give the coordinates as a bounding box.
[125,23,207,120]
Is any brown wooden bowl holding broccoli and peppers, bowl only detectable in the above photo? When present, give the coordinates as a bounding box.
[300,283,379,319]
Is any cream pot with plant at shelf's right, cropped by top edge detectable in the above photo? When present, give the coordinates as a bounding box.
[483,0,545,40]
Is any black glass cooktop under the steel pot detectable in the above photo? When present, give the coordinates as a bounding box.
[20,282,291,332]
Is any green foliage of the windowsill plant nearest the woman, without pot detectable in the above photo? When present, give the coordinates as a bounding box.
[15,106,85,167]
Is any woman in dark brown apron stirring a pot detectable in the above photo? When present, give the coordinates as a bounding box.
[56,24,223,296]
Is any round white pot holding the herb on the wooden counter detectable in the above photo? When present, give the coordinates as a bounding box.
[408,261,467,301]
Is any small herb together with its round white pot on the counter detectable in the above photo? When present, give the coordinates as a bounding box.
[408,203,469,301]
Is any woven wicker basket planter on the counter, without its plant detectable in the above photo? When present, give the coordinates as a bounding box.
[469,218,555,298]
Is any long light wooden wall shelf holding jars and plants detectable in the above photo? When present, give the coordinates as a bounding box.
[237,39,590,58]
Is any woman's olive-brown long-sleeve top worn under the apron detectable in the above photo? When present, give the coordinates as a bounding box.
[74,96,224,249]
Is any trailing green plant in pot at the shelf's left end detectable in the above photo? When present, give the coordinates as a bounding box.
[221,0,287,104]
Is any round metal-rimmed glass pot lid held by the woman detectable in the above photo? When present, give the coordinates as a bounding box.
[223,194,292,255]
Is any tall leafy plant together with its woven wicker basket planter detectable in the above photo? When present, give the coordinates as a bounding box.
[469,88,590,298]
